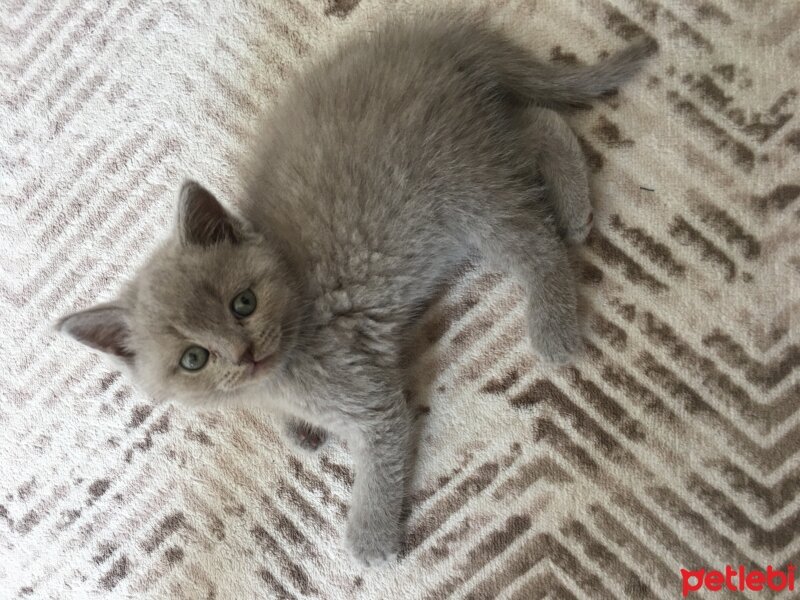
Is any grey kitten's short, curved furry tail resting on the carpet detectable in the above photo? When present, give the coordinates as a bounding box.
[472,30,658,108]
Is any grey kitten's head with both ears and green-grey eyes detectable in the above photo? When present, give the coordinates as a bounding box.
[57,181,301,406]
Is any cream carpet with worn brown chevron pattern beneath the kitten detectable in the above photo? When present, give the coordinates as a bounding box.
[0,0,800,600]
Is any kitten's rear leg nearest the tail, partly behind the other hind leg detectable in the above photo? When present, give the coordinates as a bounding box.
[525,107,594,244]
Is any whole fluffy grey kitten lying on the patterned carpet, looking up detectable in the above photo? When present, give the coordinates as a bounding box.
[59,14,654,565]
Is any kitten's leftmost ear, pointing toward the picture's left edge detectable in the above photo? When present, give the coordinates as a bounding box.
[56,304,135,364]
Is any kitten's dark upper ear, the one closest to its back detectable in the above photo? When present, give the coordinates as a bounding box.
[178,180,244,246]
